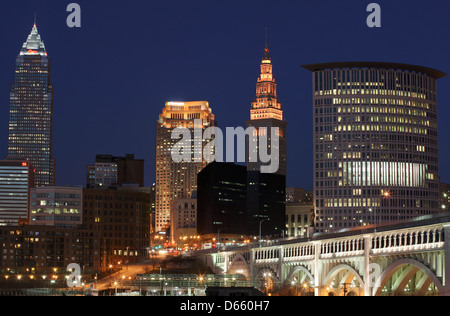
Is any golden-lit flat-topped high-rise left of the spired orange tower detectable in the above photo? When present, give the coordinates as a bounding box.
[155,101,215,232]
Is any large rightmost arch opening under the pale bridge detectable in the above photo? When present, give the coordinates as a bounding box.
[372,259,445,296]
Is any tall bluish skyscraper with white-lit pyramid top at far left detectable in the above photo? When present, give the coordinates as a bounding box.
[8,24,55,186]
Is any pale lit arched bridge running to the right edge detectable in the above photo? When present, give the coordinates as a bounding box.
[197,214,450,296]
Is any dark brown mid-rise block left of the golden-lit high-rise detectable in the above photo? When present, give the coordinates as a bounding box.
[83,187,151,269]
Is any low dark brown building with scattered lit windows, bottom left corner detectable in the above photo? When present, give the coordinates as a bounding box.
[0,225,99,276]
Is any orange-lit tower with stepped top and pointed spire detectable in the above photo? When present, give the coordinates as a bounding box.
[246,44,287,176]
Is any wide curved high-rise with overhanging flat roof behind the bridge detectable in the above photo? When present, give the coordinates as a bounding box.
[304,62,445,232]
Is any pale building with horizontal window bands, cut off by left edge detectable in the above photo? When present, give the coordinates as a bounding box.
[0,160,34,226]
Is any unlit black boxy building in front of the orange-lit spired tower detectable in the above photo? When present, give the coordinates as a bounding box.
[197,162,286,236]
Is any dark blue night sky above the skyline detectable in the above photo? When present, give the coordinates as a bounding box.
[0,0,450,189]
